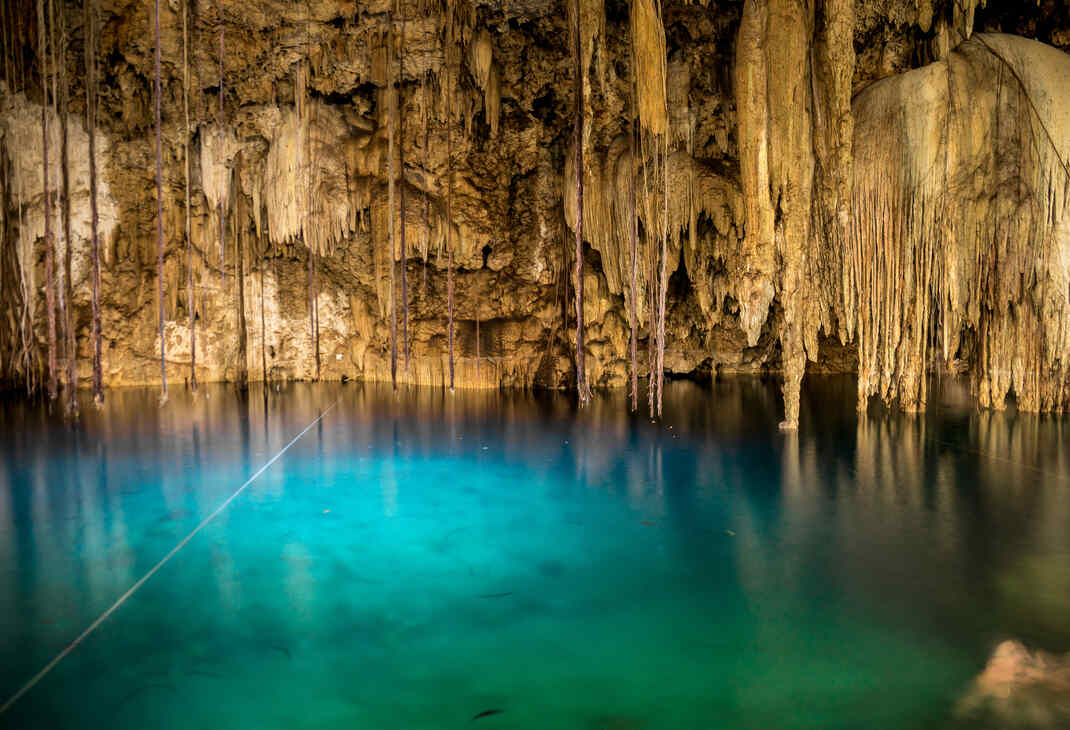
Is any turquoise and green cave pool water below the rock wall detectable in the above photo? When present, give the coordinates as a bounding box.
[0,379,1070,730]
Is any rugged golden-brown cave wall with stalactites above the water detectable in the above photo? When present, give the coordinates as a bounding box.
[0,0,1070,426]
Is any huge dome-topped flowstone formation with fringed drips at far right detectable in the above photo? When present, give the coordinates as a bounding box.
[842,34,1070,411]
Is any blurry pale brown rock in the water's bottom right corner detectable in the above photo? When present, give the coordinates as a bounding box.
[957,640,1070,728]
